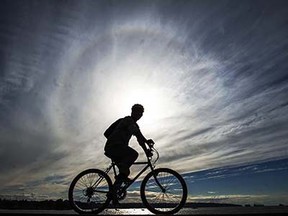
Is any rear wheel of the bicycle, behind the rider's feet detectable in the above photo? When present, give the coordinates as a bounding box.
[69,169,112,214]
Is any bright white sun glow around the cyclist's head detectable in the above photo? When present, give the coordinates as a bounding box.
[95,51,179,128]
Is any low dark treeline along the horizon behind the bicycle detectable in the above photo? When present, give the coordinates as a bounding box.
[0,199,240,210]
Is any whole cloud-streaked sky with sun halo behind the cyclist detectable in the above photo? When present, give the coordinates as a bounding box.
[0,0,288,204]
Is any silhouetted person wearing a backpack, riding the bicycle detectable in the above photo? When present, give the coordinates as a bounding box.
[104,104,154,204]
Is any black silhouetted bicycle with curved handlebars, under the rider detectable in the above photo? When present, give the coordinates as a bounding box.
[68,145,187,214]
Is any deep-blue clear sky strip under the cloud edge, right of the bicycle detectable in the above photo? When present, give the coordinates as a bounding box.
[184,159,288,205]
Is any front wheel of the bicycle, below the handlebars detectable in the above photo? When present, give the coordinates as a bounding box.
[140,168,187,214]
